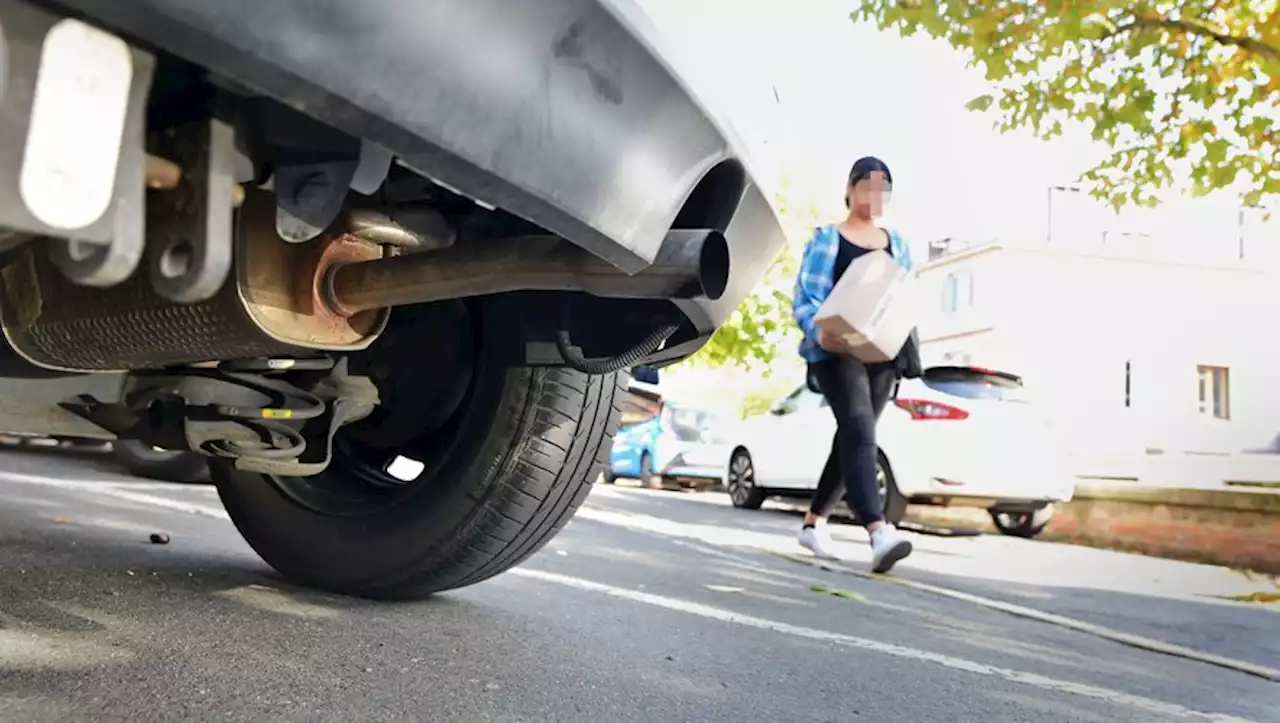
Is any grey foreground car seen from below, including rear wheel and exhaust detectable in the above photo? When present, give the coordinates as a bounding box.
[0,0,782,598]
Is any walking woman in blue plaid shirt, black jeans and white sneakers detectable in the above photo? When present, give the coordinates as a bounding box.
[792,157,911,572]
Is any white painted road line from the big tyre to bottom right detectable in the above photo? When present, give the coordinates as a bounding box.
[508,568,1248,723]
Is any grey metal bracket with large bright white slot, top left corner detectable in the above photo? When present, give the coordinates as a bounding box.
[0,0,155,287]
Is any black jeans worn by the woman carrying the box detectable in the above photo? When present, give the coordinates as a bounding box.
[809,356,897,526]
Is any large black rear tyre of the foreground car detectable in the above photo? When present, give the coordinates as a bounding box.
[211,304,625,600]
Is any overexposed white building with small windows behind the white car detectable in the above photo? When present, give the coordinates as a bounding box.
[920,234,1280,465]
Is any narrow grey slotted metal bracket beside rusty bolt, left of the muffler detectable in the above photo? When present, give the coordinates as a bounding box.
[147,118,239,303]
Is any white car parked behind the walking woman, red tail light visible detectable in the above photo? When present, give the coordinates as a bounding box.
[726,366,1075,537]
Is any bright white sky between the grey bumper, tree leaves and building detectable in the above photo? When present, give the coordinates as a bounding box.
[639,0,1280,264]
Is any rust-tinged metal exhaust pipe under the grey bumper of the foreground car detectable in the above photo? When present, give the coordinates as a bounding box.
[321,229,730,316]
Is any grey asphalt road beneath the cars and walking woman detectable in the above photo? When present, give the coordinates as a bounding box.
[0,453,1280,723]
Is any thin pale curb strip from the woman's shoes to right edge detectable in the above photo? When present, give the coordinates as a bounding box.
[755,548,1280,682]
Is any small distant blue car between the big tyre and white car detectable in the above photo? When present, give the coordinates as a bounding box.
[604,384,730,488]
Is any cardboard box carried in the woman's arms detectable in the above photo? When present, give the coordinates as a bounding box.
[814,251,916,362]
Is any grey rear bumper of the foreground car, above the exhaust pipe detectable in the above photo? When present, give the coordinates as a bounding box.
[49,0,783,337]
